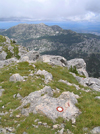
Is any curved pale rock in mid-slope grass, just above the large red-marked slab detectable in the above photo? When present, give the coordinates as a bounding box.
[36,70,53,84]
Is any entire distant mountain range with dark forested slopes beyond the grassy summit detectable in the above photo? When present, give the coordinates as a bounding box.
[0,23,100,77]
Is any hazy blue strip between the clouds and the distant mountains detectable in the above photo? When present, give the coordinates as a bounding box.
[0,21,100,34]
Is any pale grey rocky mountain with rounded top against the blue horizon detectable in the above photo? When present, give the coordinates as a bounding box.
[2,23,80,44]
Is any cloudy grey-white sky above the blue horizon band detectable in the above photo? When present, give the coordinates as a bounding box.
[0,0,100,22]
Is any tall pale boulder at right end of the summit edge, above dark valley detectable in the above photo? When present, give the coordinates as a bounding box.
[67,58,88,77]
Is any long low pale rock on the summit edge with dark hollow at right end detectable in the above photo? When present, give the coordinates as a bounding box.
[41,55,67,67]
